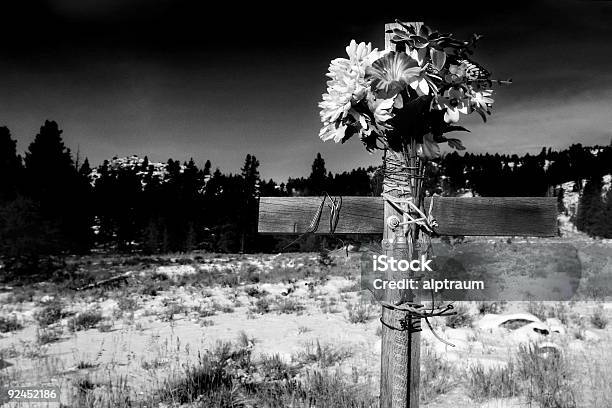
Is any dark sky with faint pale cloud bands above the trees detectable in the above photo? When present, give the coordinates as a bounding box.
[0,0,612,180]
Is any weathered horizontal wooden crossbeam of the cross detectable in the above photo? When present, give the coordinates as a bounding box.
[259,197,557,237]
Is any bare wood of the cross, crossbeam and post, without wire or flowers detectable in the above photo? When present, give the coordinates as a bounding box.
[258,23,557,408]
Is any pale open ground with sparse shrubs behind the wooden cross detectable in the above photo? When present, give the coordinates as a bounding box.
[0,239,612,408]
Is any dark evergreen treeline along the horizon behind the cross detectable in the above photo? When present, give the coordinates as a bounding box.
[0,121,612,276]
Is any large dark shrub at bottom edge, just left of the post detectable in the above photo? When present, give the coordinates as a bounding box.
[158,341,377,408]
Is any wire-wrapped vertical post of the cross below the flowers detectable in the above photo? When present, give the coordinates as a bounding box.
[380,139,455,407]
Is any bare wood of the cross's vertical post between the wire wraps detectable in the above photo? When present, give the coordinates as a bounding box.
[380,23,422,408]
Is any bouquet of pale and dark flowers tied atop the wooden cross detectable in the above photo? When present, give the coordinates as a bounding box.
[319,21,511,160]
